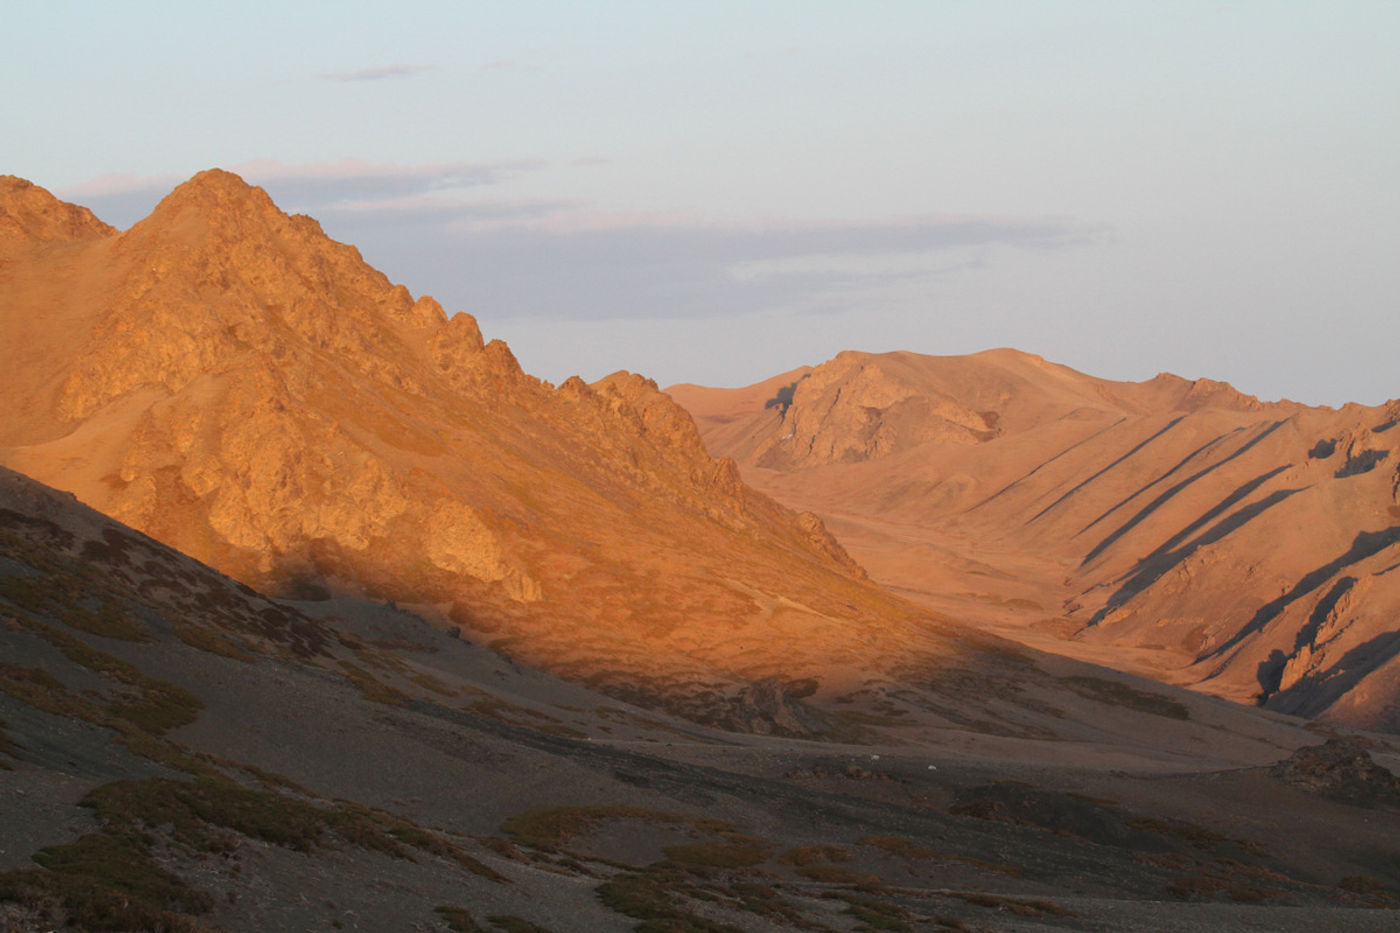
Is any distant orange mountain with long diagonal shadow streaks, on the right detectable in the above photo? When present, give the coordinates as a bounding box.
[668,350,1400,731]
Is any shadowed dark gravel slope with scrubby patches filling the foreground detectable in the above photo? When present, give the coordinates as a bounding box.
[0,472,1400,932]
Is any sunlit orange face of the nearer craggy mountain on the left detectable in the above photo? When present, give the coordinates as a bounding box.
[0,171,910,717]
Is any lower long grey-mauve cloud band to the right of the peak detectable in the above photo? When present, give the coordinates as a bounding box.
[338,202,1106,322]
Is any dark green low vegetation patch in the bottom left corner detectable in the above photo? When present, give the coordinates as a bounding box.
[0,832,216,933]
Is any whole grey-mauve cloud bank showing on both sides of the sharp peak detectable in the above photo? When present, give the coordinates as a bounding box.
[54,157,1110,354]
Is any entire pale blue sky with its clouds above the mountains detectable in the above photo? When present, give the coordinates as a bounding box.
[0,0,1400,405]
